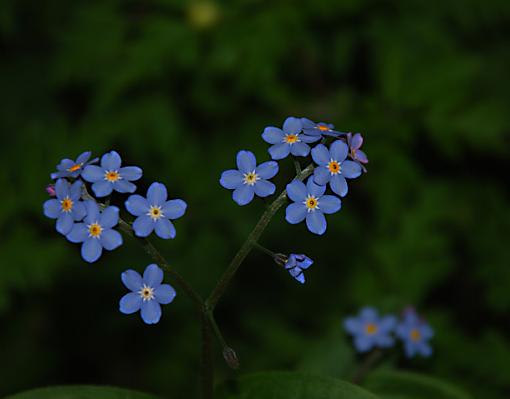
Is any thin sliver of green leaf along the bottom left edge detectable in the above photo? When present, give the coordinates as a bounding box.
[5,385,158,399]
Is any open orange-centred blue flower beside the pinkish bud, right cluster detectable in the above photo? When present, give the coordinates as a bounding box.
[312,140,361,197]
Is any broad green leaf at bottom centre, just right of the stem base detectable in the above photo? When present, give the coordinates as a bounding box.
[218,371,377,399]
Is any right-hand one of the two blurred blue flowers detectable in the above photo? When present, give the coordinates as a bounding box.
[396,309,434,357]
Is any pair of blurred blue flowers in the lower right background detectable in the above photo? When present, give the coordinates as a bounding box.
[344,307,434,357]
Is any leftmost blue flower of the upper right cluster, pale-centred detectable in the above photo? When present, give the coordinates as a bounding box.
[220,151,278,205]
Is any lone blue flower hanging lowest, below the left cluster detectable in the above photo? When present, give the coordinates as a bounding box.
[119,264,176,324]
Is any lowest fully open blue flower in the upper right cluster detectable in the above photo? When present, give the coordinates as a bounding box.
[285,177,342,235]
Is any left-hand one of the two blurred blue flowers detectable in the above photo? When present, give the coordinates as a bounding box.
[344,307,397,352]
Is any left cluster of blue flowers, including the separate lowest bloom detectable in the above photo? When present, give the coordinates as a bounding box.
[43,151,187,324]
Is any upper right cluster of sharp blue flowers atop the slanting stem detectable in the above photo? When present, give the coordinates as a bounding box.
[220,117,368,235]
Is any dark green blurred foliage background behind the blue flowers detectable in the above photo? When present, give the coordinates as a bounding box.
[0,0,510,399]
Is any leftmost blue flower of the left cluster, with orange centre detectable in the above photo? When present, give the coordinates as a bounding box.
[43,179,86,235]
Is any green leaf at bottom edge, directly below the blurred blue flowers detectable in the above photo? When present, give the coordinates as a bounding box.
[363,370,471,399]
